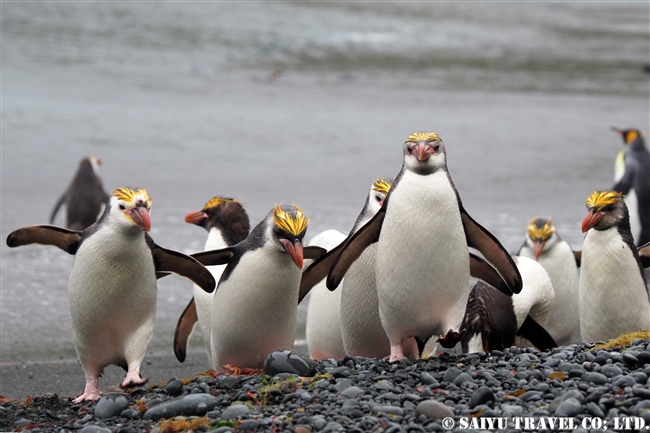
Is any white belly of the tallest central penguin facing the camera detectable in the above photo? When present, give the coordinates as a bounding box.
[375,171,470,344]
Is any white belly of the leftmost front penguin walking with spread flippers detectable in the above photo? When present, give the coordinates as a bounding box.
[68,230,157,373]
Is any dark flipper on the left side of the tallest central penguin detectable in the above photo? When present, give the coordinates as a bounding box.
[326,207,386,290]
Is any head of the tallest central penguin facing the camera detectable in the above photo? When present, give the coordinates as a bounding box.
[403,132,447,175]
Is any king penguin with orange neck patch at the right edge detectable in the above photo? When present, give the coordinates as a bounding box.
[612,128,650,246]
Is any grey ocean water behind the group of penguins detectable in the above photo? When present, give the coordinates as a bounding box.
[0,1,650,368]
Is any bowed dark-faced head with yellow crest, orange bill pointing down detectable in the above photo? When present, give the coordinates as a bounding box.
[268,205,309,269]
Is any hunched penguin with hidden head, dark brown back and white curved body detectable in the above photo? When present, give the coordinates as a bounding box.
[461,256,557,353]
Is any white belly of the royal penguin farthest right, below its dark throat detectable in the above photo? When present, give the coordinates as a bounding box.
[579,228,650,342]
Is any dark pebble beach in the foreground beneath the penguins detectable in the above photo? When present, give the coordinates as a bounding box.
[0,333,650,433]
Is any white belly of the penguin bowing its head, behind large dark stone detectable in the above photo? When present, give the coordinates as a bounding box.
[211,246,301,370]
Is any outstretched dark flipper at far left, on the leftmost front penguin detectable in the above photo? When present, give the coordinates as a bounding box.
[7,225,83,255]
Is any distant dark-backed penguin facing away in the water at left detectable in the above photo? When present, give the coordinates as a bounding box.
[50,156,109,230]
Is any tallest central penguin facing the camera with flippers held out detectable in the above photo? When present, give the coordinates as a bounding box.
[320,132,522,361]
